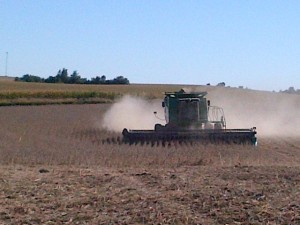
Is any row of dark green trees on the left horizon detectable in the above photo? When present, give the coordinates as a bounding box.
[15,68,129,84]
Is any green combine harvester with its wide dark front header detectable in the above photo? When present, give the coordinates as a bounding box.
[122,90,257,145]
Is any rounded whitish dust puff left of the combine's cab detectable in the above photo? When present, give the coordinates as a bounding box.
[102,96,165,132]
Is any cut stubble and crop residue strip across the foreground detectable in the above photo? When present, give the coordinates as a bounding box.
[0,166,300,224]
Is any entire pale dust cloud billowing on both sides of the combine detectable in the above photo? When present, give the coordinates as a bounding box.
[102,86,300,137]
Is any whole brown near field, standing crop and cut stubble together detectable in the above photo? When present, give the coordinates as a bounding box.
[0,104,300,224]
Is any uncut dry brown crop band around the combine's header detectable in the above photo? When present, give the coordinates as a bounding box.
[0,104,300,167]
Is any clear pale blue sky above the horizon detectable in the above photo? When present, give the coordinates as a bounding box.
[0,0,300,91]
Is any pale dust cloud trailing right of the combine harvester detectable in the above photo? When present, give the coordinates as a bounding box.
[202,88,300,136]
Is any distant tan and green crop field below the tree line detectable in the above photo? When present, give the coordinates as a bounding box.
[0,78,188,106]
